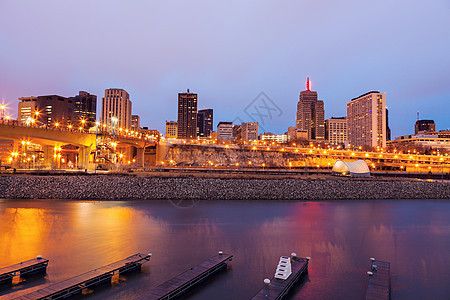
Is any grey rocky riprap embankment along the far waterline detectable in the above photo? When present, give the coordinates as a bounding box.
[0,175,450,200]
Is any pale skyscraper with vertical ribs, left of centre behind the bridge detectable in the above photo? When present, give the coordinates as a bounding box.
[102,89,131,130]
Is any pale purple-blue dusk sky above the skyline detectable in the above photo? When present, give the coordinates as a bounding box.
[0,0,450,137]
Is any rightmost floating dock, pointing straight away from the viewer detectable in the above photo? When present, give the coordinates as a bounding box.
[366,258,391,300]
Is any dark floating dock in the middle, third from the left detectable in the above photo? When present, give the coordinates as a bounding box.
[139,252,233,300]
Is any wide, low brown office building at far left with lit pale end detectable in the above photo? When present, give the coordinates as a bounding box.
[17,95,74,127]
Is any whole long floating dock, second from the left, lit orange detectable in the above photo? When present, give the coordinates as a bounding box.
[16,253,151,300]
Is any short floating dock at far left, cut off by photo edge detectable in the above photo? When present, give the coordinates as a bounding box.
[0,255,48,285]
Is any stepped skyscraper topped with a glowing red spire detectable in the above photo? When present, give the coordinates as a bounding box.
[296,77,325,141]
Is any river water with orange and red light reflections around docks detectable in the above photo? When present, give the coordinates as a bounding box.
[0,200,450,300]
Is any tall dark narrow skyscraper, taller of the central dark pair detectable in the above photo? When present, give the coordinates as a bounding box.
[178,89,197,139]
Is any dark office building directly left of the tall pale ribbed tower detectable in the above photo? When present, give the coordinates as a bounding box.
[69,91,97,123]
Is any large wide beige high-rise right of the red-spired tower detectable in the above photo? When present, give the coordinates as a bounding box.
[347,91,386,147]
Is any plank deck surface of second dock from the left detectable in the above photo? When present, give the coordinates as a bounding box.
[17,253,150,299]
